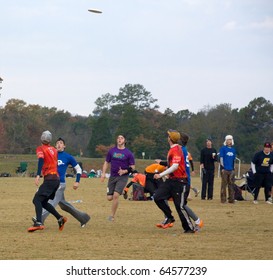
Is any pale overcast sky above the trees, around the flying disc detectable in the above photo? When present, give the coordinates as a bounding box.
[0,0,273,116]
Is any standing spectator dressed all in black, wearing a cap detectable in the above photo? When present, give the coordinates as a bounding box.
[200,138,217,200]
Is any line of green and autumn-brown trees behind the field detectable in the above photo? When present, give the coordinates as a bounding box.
[0,84,273,163]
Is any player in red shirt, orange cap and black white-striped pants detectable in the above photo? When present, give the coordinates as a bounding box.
[154,130,195,233]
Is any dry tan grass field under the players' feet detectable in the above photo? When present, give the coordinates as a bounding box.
[0,173,273,260]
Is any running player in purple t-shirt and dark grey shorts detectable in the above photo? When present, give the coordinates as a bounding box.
[101,135,135,221]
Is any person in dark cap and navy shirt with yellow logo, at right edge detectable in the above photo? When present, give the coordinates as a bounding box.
[251,142,273,204]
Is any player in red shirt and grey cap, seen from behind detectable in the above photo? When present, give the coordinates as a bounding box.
[28,130,67,232]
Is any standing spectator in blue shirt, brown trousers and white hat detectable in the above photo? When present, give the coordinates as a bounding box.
[219,135,236,203]
